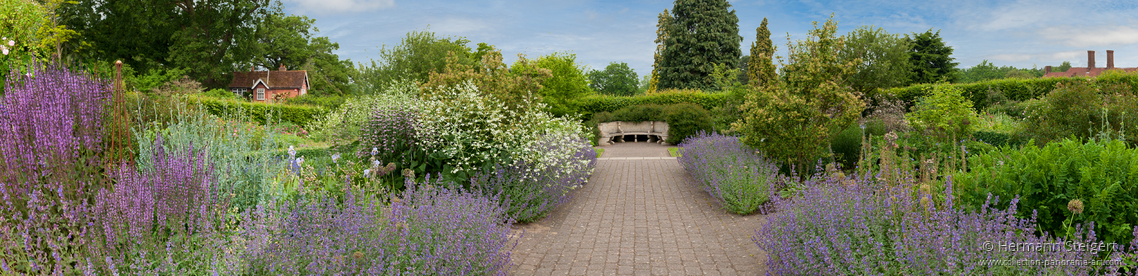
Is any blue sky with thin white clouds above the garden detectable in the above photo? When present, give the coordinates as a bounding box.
[282,0,1138,76]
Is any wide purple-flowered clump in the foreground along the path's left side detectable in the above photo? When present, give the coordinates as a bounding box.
[228,177,513,275]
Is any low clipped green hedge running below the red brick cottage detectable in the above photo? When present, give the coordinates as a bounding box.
[191,97,328,127]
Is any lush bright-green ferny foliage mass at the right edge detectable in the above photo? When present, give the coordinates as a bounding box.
[951,140,1138,244]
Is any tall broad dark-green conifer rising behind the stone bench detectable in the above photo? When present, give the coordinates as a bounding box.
[655,0,743,90]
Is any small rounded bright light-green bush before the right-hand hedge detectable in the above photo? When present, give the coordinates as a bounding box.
[906,85,980,143]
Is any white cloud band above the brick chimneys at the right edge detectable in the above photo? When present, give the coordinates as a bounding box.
[1039,25,1138,47]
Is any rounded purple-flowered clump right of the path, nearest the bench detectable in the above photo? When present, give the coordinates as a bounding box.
[678,132,782,215]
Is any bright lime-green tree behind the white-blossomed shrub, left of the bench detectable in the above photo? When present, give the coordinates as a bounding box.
[511,52,591,116]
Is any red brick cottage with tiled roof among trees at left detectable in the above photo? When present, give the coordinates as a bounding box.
[229,65,308,102]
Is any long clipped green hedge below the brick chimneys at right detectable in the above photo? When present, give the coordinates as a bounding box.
[884,74,1138,110]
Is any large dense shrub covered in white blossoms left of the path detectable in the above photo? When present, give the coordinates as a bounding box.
[417,82,592,178]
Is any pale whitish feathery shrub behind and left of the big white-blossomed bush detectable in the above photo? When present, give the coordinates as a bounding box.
[310,81,419,142]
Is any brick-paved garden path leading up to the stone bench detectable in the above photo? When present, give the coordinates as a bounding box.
[511,143,766,275]
